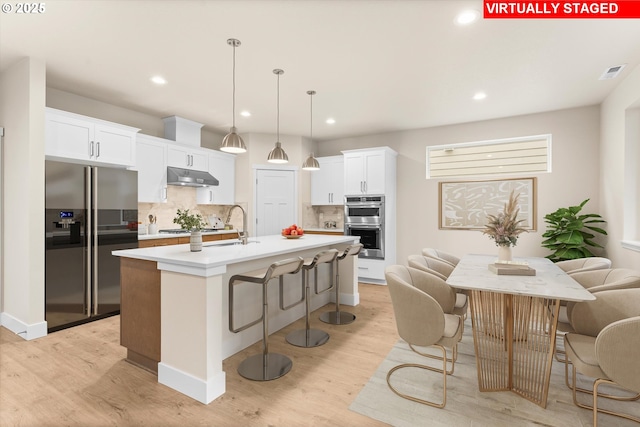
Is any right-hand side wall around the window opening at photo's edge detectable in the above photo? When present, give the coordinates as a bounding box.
[599,66,640,269]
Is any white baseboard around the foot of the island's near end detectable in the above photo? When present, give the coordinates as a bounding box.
[158,362,226,404]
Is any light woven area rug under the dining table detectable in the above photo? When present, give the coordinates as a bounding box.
[349,319,640,427]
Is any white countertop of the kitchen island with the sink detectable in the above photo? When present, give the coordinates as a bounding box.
[112,234,359,269]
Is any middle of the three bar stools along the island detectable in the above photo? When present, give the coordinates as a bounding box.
[286,249,338,348]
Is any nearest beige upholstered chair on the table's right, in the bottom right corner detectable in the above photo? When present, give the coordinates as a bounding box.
[564,288,640,426]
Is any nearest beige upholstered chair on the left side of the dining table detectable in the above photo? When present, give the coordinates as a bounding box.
[385,265,462,408]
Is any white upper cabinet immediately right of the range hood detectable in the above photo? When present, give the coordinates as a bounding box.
[196,150,236,205]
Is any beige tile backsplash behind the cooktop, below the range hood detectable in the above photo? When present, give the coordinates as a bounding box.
[138,185,248,230]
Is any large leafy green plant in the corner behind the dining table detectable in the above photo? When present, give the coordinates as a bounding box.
[542,199,607,262]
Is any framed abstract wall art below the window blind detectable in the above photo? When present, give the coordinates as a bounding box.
[438,177,536,231]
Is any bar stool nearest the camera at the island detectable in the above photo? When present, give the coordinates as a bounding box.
[229,257,304,381]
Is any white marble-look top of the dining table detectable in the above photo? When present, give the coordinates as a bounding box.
[447,255,596,301]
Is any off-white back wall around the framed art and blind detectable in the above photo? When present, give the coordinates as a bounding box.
[318,106,600,263]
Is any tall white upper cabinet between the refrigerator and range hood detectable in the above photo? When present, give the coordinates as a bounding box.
[136,134,167,203]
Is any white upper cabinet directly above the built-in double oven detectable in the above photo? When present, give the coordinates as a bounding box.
[343,147,397,195]
